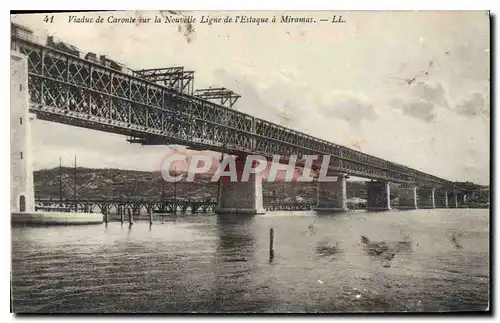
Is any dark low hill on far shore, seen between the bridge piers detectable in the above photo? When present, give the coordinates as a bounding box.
[34,167,372,203]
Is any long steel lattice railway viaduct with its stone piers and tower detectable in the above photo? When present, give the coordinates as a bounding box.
[11,25,482,214]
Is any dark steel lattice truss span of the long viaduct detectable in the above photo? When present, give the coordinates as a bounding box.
[12,37,466,187]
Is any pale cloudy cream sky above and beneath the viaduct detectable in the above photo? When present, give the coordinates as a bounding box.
[12,11,490,184]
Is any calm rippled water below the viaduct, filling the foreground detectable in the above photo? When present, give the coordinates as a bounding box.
[12,209,489,313]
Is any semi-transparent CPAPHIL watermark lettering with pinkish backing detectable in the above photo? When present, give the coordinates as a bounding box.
[160,153,337,182]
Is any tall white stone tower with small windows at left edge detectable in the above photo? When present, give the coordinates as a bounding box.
[10,52,35,213]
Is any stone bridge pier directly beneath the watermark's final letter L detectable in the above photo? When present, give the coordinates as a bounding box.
[314,174,348,212]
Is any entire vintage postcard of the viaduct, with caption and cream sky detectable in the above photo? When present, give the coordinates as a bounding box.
[10,10,491,314]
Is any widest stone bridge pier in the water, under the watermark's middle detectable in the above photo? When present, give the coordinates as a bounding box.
[215,158,266,214]
